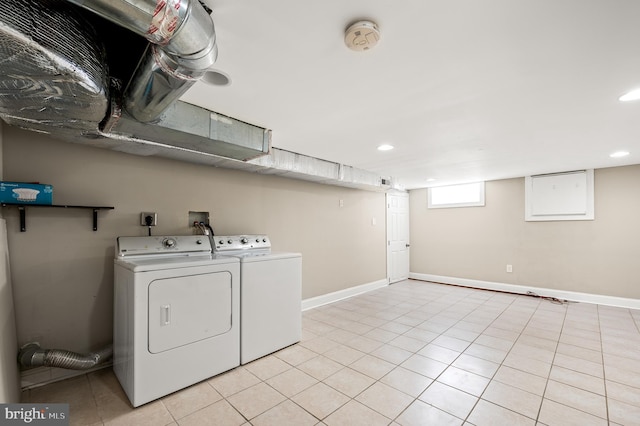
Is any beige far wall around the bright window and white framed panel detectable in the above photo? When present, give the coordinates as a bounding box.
[410,166,640,299]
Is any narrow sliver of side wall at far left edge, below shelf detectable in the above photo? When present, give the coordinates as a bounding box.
[0,120,20,403]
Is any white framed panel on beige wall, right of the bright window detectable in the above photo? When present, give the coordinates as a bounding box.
[524,169,595,221]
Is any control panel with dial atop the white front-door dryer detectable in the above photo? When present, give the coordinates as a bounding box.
[116,235,212,258]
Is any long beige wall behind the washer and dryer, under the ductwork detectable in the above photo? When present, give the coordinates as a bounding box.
[4,126,386,358]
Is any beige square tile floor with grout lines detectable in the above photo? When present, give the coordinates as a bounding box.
[23,280,640,426]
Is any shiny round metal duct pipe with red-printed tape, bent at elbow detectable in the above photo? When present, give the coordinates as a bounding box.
[69,0,218,122]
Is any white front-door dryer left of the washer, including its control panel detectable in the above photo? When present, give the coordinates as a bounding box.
[113,235,240,407]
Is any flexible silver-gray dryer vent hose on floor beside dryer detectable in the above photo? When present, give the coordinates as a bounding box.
[18,343,113,370]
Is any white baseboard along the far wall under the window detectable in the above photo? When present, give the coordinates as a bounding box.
[409,272,640,309]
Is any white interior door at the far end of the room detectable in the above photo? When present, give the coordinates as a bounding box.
[387,193,410,283]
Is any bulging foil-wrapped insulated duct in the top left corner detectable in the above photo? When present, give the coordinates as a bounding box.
[0,0,108,134]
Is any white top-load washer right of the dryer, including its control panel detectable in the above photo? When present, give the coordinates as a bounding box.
[213,235,302,364]
